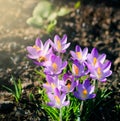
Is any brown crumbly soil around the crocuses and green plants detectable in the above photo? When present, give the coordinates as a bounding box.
[0,0,120,121]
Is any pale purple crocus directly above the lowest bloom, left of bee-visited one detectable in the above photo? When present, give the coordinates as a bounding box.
[43,75,64,93]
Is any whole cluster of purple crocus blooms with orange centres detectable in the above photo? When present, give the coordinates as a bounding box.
[27,35,112,109]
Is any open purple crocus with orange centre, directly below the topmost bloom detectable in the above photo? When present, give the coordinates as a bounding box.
[44,54,67,75]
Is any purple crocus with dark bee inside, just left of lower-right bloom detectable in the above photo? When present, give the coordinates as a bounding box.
[62,74,78,93]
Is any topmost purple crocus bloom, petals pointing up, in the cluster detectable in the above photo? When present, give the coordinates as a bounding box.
[51,35,70,53]
